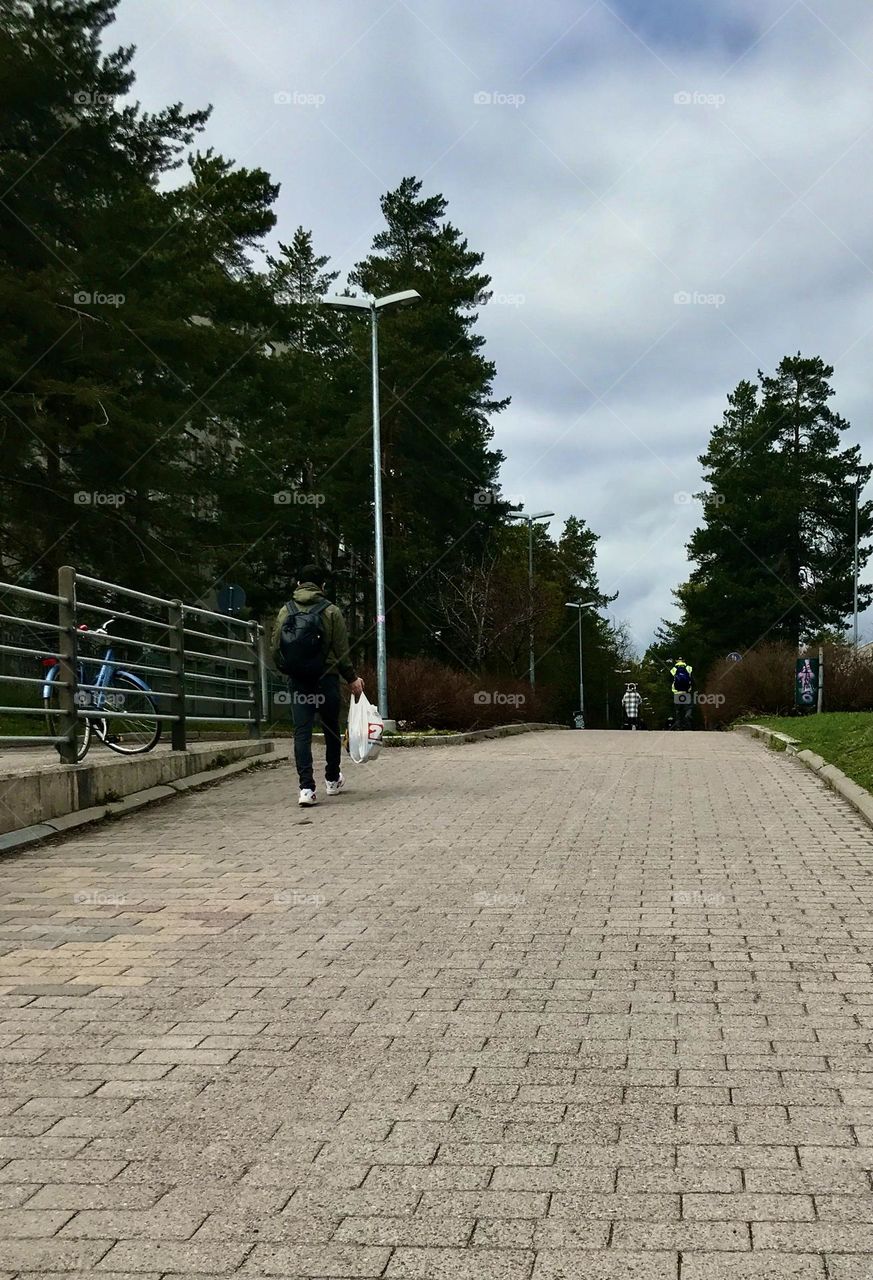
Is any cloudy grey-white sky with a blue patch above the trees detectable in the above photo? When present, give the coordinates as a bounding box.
[108,0,873,649]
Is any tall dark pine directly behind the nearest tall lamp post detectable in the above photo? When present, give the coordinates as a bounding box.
[348,178,508,649]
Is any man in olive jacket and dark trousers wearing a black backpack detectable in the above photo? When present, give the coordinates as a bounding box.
[273,564,364,806]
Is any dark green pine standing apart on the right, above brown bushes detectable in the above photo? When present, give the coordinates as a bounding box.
[676,356,873,663]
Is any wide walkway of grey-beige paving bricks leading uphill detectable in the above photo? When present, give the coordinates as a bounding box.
[0,732,873,1280]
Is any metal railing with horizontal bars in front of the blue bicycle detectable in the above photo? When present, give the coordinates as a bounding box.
[0,566,268,763]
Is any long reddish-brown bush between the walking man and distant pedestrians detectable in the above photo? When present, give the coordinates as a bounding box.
[362,658,549,731]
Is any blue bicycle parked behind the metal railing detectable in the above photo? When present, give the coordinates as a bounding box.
[42,618,161,760]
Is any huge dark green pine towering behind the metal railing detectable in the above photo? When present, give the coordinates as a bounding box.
[0,0,278,595]
